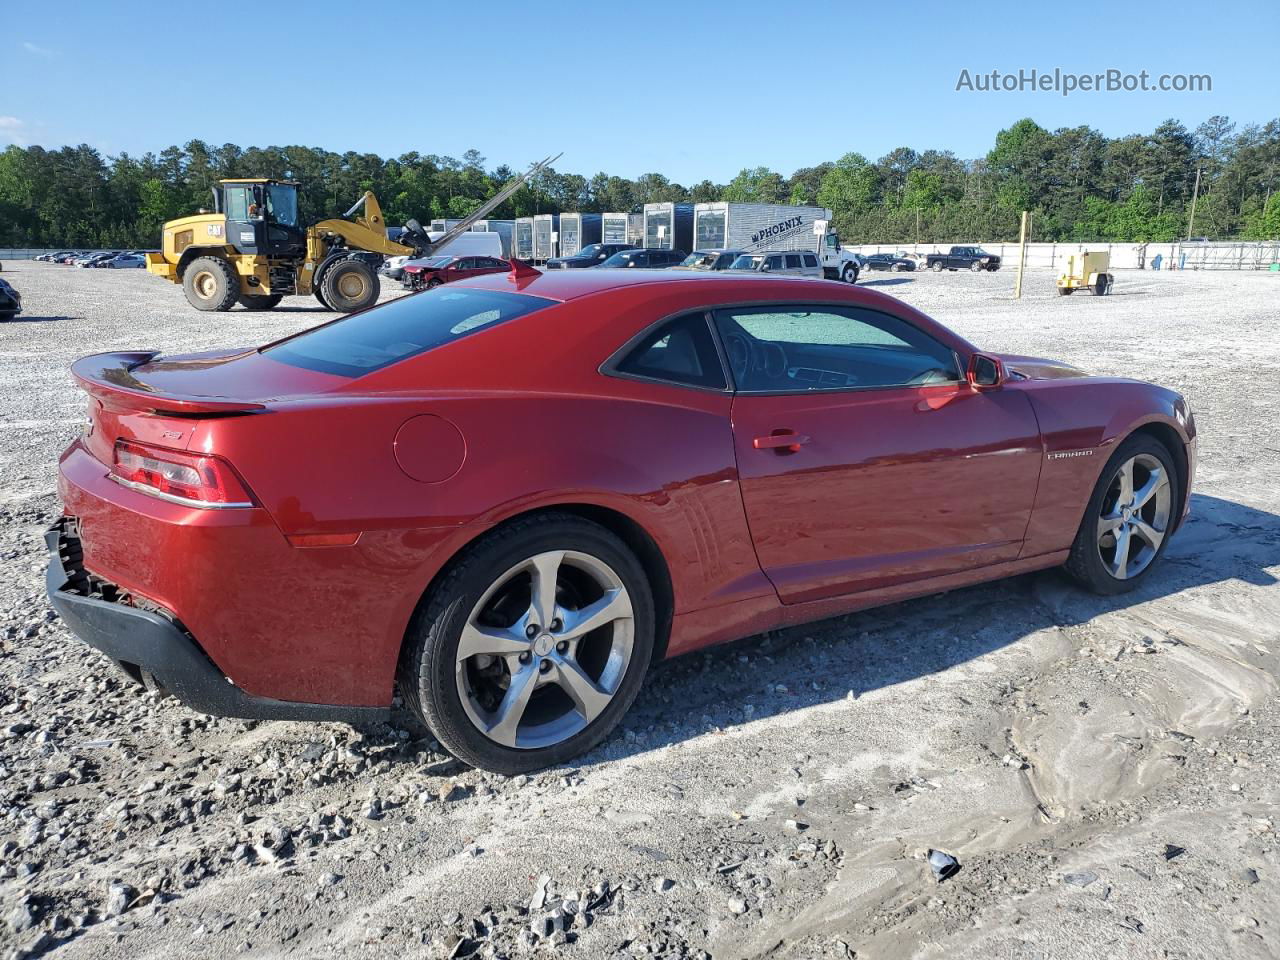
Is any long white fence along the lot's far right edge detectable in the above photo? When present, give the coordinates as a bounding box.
[849,241,1280,270]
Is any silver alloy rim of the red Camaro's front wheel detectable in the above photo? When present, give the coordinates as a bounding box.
[1097,453,1172,580]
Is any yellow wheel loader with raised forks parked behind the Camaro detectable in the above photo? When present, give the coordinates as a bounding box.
[147,155,559,314]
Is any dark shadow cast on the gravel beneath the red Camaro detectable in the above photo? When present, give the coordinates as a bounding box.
[365,494,1280,776]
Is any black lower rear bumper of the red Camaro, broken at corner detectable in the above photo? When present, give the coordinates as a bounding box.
[45,517,389,723]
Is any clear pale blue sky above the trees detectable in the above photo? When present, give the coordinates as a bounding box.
[0,0,1280,184]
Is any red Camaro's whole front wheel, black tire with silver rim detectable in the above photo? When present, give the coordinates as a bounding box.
[1066,434,1183,595]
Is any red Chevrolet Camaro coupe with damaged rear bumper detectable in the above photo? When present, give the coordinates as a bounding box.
[49,265,1196,772]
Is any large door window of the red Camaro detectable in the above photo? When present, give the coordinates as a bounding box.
[716,306,960,393]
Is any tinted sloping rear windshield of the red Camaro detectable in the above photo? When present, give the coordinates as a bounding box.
[262,287,556,376]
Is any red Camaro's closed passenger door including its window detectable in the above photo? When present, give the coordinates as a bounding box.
[714,305,1041,603]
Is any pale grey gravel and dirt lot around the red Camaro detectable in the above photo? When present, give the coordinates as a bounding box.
[0,262,1280,960]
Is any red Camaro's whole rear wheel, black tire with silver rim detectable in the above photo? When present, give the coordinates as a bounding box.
[399,513,654,774]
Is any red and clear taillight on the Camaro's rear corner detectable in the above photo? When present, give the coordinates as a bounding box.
[111,440,253,507]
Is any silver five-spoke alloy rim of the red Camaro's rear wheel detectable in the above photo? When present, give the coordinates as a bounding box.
[456,550,635,750]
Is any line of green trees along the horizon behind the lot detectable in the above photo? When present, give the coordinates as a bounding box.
[0,116,1280,247]
